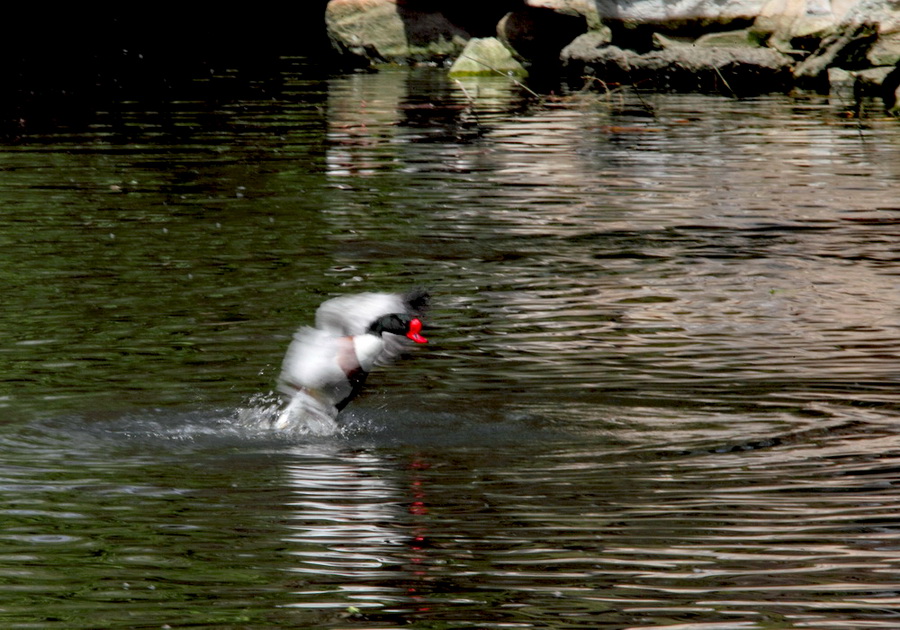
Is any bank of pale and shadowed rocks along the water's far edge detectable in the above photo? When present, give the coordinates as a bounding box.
[325,0,900,114]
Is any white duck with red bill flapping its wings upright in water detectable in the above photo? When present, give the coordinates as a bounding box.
[275,289,429,433]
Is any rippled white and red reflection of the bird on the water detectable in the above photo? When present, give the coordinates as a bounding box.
[285,452,428,609]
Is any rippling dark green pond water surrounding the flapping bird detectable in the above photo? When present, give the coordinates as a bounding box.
[0,61,900,630]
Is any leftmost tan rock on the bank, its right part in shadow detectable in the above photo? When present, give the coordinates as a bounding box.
[325,0,470,63]
